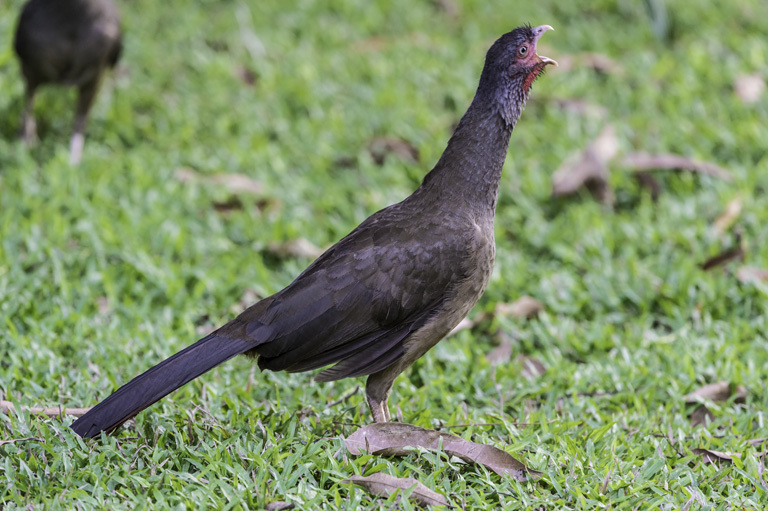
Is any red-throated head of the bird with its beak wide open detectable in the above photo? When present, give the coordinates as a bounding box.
[479,25,557,126]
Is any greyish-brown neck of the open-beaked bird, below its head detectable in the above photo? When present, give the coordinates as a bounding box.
[421,85,520,219]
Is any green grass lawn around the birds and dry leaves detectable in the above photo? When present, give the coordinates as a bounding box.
[0,0,768,510]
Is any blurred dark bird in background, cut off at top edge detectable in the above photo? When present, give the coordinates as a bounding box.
[14,0,122,165]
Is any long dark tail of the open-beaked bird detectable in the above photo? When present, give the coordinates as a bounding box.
[71,330,254,438]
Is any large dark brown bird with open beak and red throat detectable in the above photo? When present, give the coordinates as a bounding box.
[72,25,556,437]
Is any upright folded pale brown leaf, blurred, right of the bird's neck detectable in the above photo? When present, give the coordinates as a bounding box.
[552,124,619,204]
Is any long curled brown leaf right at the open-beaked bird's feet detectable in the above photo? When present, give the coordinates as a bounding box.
[344,422,541,481]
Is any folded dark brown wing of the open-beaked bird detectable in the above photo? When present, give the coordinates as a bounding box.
[236,205,465,380]
